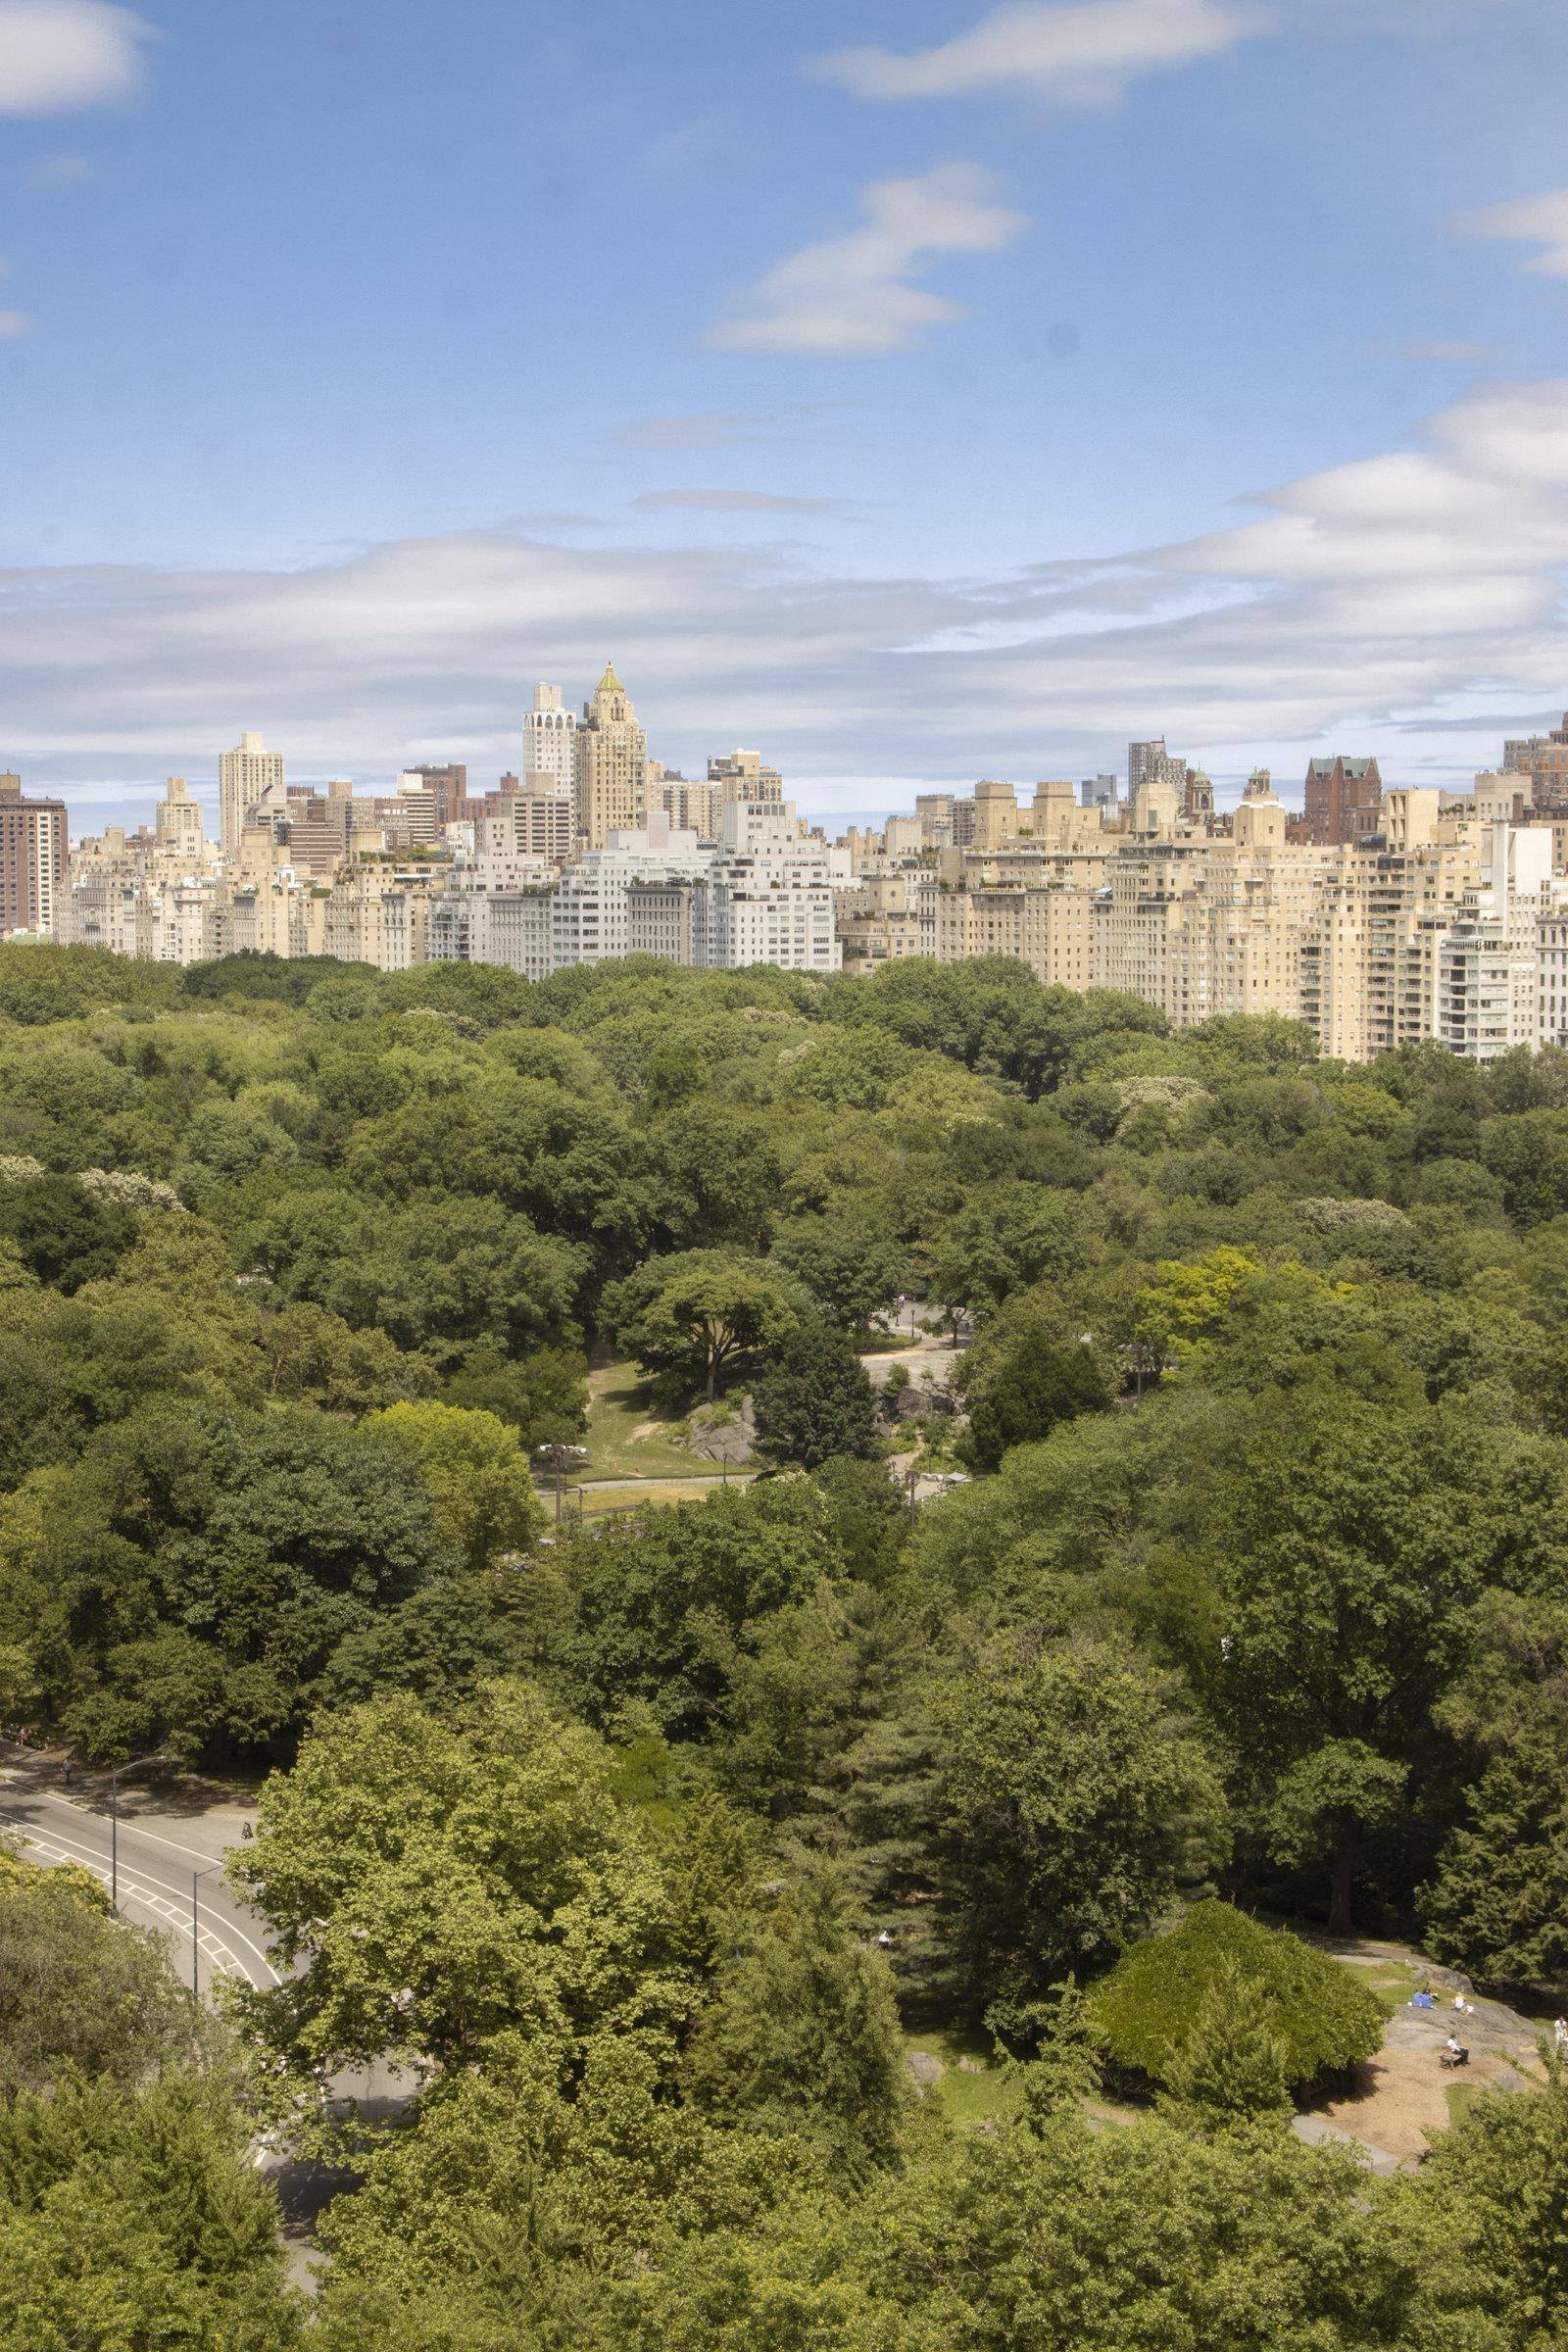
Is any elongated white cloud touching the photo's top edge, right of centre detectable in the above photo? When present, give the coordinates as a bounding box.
[818,0,1267,106]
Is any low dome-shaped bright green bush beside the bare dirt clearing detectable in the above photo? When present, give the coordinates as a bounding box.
[1093,1903,1382,2088]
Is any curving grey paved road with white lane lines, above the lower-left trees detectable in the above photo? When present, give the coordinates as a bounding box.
[0,1764,279,1992]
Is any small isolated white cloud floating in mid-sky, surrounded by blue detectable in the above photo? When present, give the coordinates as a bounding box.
[710,163,1025,358]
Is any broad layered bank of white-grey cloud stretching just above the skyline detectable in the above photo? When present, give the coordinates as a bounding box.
[0,368,1568,809]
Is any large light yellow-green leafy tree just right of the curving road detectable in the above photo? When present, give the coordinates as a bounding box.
[228,1682,691,2077]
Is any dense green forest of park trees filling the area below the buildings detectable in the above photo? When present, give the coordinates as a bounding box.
[0,948,1568,2352]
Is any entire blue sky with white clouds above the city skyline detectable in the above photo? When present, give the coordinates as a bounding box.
[0,0,1568,823]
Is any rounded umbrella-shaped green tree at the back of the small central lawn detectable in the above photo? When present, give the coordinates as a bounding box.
[604,1249,800,1404]
